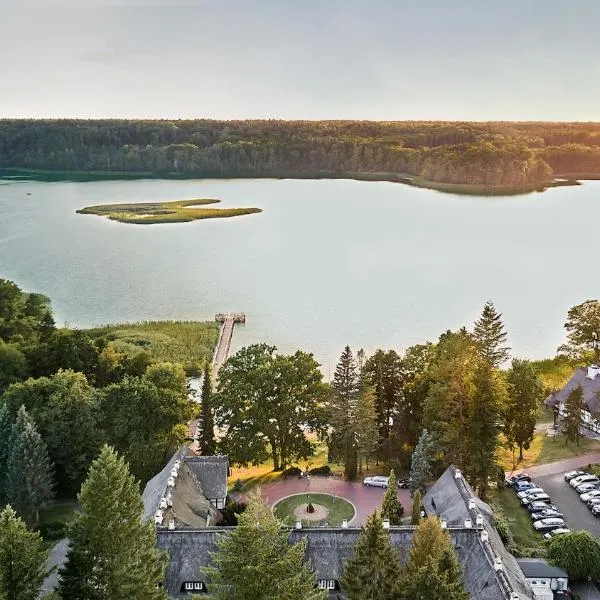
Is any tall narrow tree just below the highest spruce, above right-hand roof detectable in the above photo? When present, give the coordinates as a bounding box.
[465,360,507,499]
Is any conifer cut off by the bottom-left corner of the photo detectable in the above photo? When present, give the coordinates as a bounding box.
[0,506,48,600]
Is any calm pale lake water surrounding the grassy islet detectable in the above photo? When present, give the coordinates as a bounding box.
[0,179,600,376]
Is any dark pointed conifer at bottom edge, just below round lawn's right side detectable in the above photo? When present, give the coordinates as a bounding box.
[341,513,401,600]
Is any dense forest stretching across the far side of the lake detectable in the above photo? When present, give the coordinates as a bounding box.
[0,120,600,187]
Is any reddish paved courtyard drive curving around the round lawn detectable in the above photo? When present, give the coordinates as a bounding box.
[262,477,412,525]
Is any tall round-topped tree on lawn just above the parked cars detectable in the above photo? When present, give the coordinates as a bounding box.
[504,359,544,460]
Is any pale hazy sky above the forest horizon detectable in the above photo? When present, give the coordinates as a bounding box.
[0,0,600,121]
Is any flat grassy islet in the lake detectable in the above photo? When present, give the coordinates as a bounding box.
[77,198,262,225]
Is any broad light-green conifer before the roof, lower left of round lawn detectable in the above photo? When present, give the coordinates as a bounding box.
[202,494,325,600]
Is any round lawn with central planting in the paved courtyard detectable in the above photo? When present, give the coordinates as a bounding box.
[273,494,354,527]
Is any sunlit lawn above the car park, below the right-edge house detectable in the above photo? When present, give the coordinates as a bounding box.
[498,432,600,472]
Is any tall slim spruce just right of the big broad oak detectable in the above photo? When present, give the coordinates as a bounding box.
[330,346,360,479]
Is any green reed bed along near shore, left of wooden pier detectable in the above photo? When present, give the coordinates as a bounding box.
[88,321,219,375]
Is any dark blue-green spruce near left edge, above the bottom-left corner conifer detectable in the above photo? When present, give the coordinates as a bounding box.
[6,406,52,525]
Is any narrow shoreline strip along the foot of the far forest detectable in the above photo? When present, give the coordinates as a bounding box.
[0,167,584,196]
